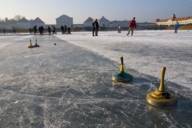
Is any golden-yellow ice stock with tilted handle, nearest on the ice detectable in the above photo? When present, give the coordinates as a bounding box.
[146,67,177,107]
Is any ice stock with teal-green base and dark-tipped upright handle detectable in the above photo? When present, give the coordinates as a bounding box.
[112,57,133,83]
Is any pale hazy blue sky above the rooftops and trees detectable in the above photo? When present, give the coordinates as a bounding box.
[0,0,192,23]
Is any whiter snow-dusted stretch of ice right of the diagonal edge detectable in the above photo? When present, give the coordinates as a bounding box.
[57,30,192,89]
